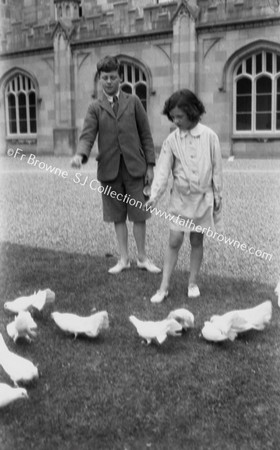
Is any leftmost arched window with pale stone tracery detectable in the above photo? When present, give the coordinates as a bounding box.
[5,74,37,137]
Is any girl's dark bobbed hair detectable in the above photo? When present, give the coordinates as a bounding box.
[163,89,206,122]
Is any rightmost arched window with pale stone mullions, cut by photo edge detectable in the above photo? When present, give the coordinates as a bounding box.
[233,51,280,135]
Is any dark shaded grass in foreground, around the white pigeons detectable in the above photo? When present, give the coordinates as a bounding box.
[0,242,280,450]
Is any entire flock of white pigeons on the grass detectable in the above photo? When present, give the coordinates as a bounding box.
[0,281,280,408]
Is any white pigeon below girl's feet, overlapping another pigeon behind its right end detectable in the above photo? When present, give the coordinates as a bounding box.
[129,316,182,344]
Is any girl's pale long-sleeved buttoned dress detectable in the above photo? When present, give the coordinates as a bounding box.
[150,123,223,233]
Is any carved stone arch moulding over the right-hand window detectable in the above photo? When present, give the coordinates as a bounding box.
[219,39,280,92]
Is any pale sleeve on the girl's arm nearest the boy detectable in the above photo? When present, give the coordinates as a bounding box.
[150,140,174,202]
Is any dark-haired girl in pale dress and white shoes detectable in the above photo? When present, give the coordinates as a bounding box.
[146,89,222,303]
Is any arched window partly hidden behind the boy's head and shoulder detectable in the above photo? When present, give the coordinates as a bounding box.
[118,61,147,110]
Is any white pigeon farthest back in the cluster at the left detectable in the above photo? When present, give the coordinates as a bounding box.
[4,289,55,314]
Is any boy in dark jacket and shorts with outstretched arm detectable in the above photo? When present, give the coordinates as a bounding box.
[71,56,161,274]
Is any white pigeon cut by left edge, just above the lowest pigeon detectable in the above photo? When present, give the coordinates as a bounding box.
[0,333,39,386]
